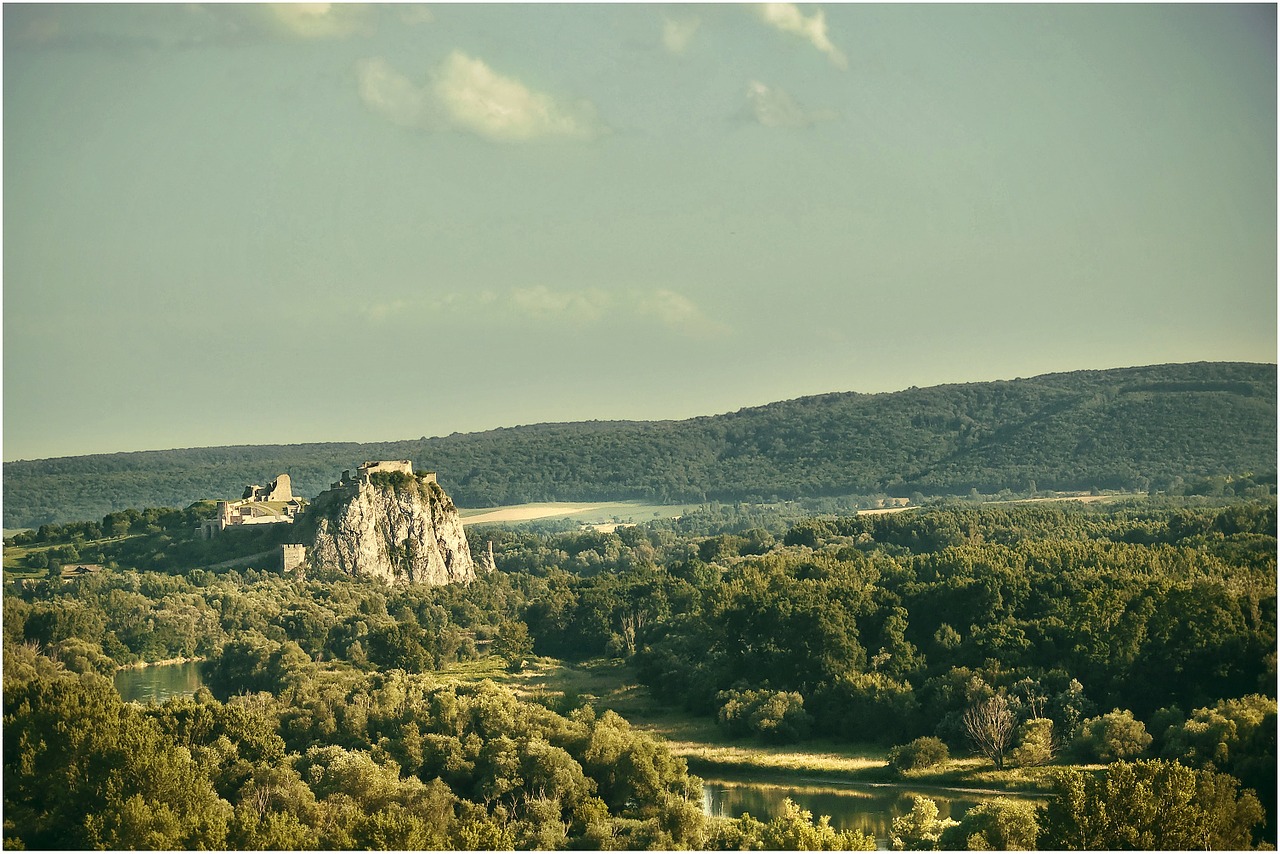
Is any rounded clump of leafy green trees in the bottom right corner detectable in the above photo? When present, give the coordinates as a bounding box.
[1039,759,1263,850]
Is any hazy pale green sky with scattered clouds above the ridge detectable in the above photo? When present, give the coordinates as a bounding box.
[3,3,1277,460]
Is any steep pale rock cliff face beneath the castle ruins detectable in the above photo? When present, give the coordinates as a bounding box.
[308,474,476,585]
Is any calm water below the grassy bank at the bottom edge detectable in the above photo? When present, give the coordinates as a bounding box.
[703,780,1029,849]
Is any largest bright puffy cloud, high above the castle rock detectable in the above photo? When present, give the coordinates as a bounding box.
[356,51,605,142]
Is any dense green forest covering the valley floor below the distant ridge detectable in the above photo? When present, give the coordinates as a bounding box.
[4,497,1276,849]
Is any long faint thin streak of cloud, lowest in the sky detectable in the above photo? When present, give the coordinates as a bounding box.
[360,284,730,338]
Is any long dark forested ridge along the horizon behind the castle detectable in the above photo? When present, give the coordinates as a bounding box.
[4,362,1276,528]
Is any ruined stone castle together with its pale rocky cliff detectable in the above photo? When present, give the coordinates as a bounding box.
[198,460,476,584]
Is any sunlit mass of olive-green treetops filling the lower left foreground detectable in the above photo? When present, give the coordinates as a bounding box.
[4,647,732,850]
